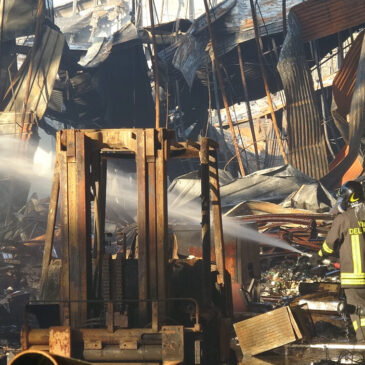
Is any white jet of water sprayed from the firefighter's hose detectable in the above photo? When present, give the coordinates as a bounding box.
[0,137,312,257]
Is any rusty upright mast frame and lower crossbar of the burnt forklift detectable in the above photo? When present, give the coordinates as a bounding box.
[22,128,231,364]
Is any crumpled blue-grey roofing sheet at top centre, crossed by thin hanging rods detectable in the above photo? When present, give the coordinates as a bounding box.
[166,0,301,86]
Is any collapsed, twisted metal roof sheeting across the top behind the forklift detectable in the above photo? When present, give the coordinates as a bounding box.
[0,0,365,199]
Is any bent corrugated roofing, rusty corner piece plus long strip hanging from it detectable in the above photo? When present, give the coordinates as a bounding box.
[278,0,365,184]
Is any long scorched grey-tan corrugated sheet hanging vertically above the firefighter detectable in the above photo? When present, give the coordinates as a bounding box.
[278,13,328,179]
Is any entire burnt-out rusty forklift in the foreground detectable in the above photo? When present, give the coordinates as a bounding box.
[17,129,232,365]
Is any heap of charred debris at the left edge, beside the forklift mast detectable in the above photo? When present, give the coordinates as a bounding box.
[0,194,49,347]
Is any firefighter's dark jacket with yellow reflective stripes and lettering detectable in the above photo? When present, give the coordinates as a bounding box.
[318,203,365,288]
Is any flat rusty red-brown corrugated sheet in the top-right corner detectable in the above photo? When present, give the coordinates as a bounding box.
[291,0,365,42]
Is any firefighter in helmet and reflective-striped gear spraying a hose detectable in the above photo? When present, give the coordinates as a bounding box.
[318,181,365,342]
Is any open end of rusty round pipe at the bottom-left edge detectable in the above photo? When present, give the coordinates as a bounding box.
[9,350,90,365]
